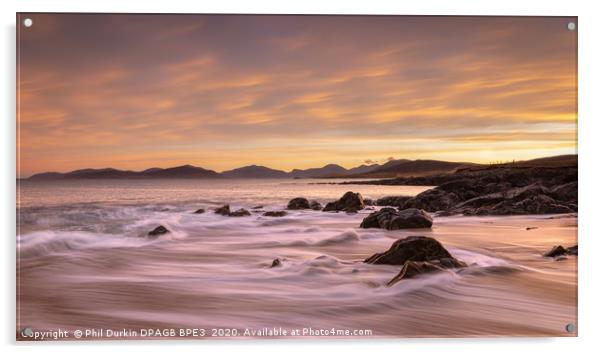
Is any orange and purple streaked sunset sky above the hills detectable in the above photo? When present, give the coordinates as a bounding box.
[17,14,577,177]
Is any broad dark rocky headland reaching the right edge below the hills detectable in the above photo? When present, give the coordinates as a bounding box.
[345,161,578,216]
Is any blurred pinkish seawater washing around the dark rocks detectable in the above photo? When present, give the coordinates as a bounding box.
[17,180,577,337]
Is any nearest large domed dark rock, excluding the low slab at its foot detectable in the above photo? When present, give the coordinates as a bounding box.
[364,236,466,268]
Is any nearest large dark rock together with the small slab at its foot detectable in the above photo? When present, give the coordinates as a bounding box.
[364,236,466,286]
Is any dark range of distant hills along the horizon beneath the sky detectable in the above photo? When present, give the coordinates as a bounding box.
[29,155,577,180]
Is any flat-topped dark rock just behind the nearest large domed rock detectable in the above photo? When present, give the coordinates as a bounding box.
[360,208,433,230]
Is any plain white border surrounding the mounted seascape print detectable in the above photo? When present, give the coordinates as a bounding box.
[0,0,602,354]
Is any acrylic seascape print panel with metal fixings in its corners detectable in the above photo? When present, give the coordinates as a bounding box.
[16,13,578,341]
